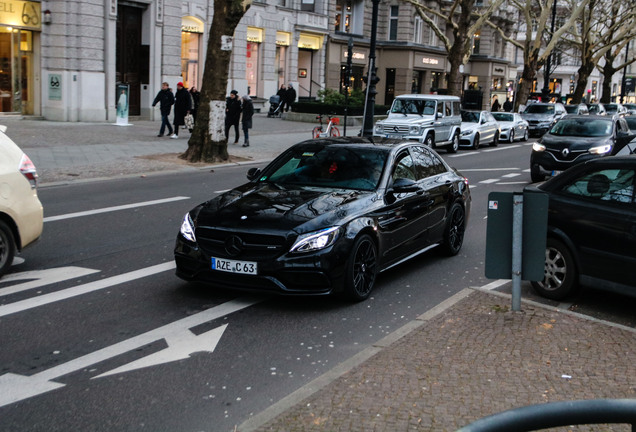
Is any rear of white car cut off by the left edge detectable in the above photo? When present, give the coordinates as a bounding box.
[0,126,43,277]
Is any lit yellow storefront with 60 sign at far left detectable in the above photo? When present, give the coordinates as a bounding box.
[0,0,42,114]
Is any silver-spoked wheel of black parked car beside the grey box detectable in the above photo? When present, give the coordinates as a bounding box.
[532,238,577,300]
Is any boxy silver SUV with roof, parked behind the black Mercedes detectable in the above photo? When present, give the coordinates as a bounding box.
[373,94,462,153]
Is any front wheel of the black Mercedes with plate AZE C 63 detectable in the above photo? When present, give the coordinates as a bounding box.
[345,234,378,301]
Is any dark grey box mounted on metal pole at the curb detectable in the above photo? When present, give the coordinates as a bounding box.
[486,191,548,281]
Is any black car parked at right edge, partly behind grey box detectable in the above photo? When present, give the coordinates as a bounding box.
[527,155,636,300]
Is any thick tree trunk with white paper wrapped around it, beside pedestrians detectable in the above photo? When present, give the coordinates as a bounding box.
[180,0,251,162]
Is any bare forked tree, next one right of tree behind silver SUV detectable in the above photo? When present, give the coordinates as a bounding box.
[487,0,589,111]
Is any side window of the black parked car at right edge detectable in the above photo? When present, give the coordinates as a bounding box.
[563,169,634,203]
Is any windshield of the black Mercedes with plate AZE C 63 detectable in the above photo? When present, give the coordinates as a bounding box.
[259,144,388,191]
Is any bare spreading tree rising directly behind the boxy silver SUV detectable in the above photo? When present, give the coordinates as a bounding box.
[402,0,504,96]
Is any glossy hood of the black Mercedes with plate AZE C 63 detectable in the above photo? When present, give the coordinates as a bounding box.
[192,183,379,233]
